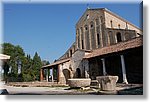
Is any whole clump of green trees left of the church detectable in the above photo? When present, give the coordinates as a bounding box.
[2,43,45,81]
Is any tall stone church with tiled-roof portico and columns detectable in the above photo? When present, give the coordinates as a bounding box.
[40,8,143,84]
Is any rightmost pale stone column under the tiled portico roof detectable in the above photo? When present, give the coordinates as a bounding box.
[120,55,128,84]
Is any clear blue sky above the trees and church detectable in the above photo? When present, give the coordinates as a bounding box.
[3,3,141,62]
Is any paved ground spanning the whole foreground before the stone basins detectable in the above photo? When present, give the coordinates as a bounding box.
[1,83,143,95]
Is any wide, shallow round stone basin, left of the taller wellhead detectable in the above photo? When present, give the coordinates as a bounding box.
[68,78,91,88]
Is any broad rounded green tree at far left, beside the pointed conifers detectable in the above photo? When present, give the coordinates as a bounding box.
[2,43,25,79]
